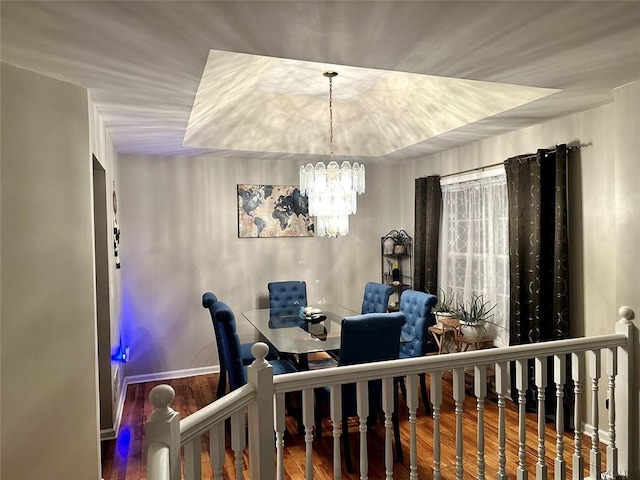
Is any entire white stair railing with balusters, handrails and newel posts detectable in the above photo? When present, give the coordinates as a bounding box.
[145,307,638,480]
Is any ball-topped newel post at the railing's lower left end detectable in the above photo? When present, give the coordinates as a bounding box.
[144,385,180,480]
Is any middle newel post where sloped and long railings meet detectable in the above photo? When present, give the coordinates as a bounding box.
[247,342,275,480]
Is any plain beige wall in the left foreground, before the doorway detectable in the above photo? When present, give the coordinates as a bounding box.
[0,64,100,480]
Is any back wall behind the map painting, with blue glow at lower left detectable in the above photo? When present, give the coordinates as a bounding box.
[120,156,392,376]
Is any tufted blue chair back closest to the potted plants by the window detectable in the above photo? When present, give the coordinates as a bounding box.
[400,290,437,358]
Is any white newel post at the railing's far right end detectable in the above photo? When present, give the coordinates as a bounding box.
[610,307,638,478]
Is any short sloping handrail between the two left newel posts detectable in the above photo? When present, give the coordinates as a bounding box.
[180,384,257,445]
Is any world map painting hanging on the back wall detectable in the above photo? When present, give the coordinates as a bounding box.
[238,184,315,238]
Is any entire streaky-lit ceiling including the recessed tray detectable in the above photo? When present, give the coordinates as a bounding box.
[0,0,640,163]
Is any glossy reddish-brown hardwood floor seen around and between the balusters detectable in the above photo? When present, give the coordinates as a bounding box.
[103,375,606,480]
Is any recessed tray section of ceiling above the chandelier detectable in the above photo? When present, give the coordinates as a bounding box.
[184,50,556,157]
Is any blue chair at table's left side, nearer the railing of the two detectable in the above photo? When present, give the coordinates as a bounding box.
[213,301,298,391]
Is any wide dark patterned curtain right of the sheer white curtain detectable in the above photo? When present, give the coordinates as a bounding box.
[504,145,570,420]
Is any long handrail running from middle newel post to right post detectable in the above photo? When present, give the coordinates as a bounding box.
[273,333,627,393]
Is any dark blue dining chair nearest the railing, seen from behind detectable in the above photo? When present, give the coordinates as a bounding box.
[338,312,405,472]
